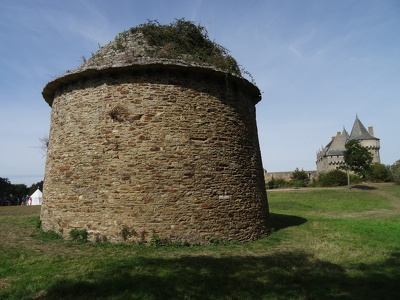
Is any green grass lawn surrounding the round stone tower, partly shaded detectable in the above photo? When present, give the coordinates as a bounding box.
[0,184,400,300]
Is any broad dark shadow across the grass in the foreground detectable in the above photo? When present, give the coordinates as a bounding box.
[36,252,400,300]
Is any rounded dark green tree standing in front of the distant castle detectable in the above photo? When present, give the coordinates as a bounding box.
[344,140,372,184]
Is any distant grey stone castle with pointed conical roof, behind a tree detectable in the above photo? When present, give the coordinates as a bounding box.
[316,116,380,173]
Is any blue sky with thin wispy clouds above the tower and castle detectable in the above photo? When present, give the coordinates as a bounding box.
[0,0,400,186]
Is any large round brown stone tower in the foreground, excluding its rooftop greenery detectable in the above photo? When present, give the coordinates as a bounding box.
[41,21,268,244]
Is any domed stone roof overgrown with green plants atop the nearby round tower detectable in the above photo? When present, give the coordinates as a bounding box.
[42,20,261,106]
